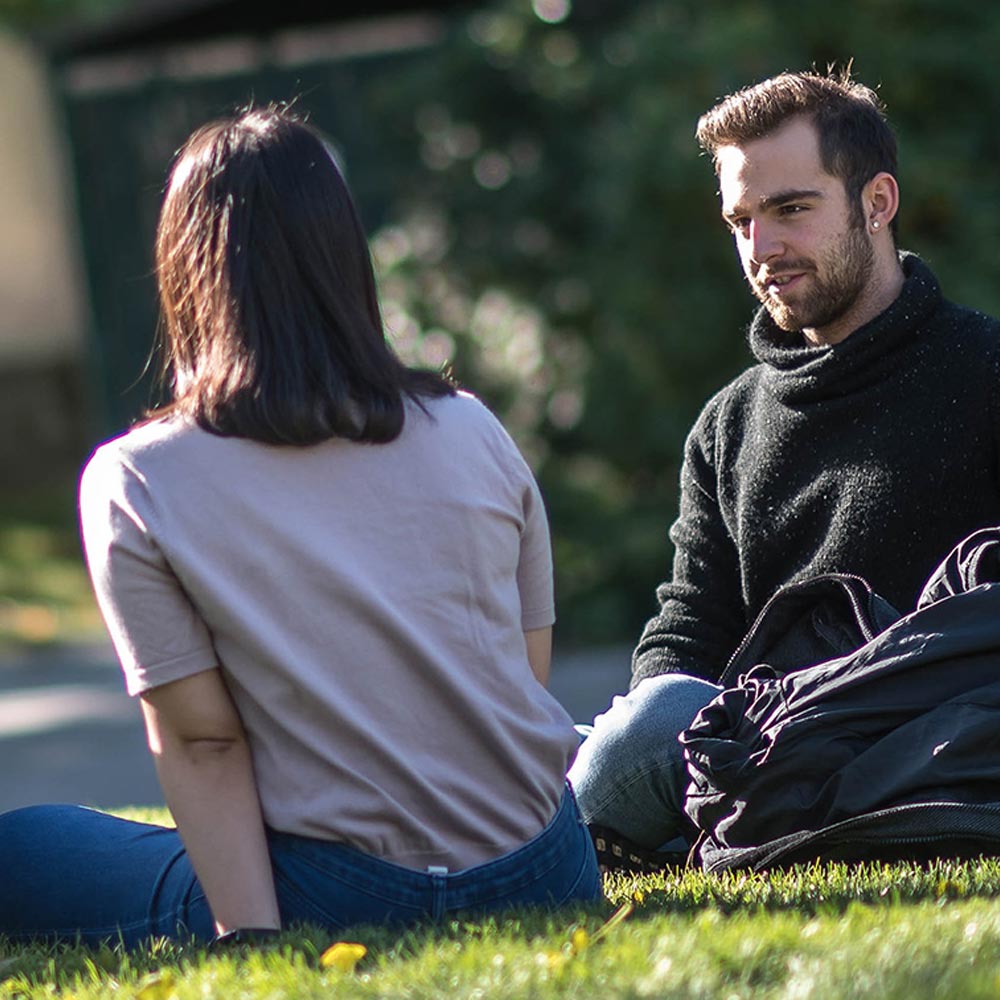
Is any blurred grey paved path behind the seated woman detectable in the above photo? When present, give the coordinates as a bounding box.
[0,644,629,811]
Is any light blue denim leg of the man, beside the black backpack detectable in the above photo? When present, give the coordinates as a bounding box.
[568,674,722,850]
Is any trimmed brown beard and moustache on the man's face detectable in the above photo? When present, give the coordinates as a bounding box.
[750,226,875,332]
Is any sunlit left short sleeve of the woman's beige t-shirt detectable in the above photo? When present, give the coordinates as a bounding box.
[80,442,217,695]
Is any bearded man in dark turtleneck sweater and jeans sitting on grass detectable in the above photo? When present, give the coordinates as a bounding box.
[569,73,1000,850]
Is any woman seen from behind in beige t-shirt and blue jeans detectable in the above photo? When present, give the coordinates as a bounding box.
[0,108,600,945]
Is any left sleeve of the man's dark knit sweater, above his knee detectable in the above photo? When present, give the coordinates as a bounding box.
[632,397,747,687]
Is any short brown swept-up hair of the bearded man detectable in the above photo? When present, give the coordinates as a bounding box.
[695,68,896,226]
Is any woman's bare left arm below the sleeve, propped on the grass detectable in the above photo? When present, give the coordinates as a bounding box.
[141,667,281,934]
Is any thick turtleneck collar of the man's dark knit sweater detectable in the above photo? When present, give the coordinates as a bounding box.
[748,251,941,403]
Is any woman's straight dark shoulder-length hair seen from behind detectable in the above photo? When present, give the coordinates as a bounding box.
[149,106,455,445]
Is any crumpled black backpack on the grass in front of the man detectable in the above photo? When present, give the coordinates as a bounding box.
[681,529,1000,871]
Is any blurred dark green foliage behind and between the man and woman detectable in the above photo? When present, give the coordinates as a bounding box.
[366,0,1000,642]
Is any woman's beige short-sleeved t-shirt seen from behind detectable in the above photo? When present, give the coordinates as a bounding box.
[80,393,578,871]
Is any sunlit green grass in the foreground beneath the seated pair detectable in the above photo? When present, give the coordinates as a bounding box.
[0,840,1000,1000]
